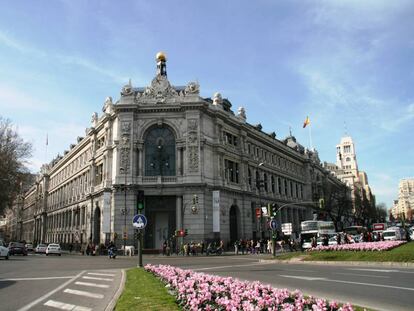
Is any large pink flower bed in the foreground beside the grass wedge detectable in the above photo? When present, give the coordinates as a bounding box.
[145,265,353,311]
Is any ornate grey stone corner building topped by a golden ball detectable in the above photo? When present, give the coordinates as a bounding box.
[5,53,350,249]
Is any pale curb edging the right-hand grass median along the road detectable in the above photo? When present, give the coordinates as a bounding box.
[260,259,414,268]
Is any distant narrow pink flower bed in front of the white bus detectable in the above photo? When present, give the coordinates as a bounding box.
[309,241,406,251]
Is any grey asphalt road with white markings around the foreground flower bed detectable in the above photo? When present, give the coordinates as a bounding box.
[0,255,414,311]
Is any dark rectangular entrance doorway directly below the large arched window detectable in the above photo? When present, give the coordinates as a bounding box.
[144,196,176,249]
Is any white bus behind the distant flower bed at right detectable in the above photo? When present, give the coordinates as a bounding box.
[300,220,336,249]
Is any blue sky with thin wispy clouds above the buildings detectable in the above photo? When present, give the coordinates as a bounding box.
[0,0,414,208]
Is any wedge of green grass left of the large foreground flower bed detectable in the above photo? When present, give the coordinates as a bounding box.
[115,268,180,311]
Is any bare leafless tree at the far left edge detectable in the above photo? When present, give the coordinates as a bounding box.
[0,116,32,214]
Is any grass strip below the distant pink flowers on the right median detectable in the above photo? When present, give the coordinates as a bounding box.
[276,242,414,263]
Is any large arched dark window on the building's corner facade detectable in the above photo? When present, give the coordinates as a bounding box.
[145,127,176,176]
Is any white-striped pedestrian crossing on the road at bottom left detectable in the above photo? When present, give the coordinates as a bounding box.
[42,271,119,311]
